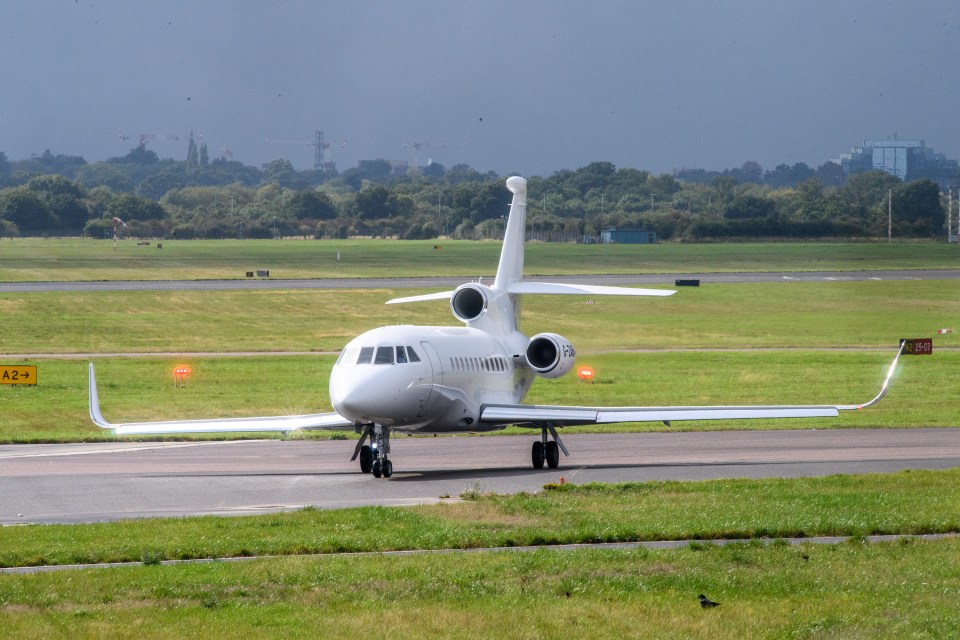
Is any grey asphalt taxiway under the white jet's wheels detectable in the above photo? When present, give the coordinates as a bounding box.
[0,429,960,525]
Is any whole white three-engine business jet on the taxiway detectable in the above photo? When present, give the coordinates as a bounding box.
[90,177,902,478]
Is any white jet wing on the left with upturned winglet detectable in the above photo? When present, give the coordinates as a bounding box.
[90,363,353,435]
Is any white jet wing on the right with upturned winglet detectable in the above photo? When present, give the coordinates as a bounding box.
[480,344,904,428]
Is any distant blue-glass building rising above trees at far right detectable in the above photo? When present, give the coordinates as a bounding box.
[840,136,958,191]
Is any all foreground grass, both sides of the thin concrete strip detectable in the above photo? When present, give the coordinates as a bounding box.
[0,471,960,638]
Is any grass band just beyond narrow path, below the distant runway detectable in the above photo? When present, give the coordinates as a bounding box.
[0,280,960,354]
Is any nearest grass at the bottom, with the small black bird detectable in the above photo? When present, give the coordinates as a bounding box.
[0,540,960,640]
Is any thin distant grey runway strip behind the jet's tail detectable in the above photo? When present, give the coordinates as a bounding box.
[0,269,960,293]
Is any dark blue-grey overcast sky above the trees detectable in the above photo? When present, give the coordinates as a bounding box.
[0,0,960,176]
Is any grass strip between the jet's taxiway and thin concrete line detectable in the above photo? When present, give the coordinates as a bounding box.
[0,469,960,566]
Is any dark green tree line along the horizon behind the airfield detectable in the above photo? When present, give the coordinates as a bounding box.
[0,140,946,241]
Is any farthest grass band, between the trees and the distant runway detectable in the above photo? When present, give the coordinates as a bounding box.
[0,238,957,282]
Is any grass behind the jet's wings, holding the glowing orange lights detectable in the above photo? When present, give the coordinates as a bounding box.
[0,349,960,443]
